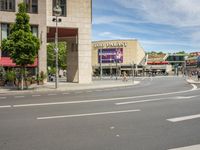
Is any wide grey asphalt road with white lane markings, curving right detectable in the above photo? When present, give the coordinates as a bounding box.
[0,77,200,150]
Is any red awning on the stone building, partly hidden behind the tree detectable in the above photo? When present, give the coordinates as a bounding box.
[0,57,38,67]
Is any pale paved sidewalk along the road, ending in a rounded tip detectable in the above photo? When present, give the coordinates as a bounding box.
[0,79,140,94]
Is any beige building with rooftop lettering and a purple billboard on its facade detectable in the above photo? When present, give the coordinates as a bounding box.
[92,40,145,76]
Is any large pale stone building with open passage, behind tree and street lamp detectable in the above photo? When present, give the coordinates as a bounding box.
[0,0,92,83]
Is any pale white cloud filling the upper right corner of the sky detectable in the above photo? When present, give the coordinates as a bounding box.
[115,0,200,27]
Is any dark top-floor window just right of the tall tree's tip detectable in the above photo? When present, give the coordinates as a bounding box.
[24,0,38,14]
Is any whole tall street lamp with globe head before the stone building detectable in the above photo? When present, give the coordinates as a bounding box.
[52,4,62,89]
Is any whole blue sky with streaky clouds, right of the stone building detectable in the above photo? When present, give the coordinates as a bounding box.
[92,0,200,52]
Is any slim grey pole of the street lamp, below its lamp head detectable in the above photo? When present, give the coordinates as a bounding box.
[55,16,58,89]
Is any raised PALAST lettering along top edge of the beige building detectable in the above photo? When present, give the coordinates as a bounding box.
[94,42,127,48]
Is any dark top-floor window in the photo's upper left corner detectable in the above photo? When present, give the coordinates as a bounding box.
[0,0,15,11]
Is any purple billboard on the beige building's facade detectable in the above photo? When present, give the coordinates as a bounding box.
[98,48,123,63]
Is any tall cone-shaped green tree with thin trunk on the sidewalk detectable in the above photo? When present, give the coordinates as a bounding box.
[2,3,40,90]
